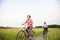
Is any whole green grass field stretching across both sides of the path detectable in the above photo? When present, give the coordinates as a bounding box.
[0,28,60,40]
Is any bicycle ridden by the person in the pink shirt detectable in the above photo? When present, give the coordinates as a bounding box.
[16,24,35,40]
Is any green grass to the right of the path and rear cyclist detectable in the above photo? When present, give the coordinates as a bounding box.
[46,28,60,40]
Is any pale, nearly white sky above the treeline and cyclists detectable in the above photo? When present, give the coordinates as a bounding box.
[0,0,60,27]
